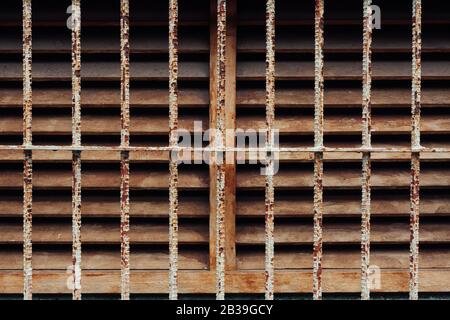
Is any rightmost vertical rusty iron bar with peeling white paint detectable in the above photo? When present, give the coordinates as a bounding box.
[409,0,422,300]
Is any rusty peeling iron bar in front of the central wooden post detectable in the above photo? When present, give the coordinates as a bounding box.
[214,0,227,300]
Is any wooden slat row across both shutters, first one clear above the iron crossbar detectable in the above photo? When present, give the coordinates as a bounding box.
[0,112,450,135]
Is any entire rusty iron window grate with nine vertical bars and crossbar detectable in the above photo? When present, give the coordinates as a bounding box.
[0,0,450,299]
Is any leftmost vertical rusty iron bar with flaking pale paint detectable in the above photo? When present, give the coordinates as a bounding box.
[23,0,33,300]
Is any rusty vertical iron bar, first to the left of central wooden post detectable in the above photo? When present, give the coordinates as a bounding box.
[169,0,178,300]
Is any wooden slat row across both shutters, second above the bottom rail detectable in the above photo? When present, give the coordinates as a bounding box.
[0,220,450,245]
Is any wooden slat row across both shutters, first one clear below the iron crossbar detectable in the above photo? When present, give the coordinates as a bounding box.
[0,164,450,189]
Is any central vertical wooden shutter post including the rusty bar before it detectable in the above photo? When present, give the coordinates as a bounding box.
[210,0,237,299]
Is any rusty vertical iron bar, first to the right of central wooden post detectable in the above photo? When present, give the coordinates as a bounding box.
[265,0,275,300]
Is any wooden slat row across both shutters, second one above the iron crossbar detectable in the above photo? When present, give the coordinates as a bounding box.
[0,87,450,108]
